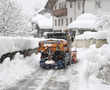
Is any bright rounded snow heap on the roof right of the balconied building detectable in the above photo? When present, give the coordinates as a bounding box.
[68,13,97,30]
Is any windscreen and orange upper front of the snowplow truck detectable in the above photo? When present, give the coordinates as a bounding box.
[38,32,69,52]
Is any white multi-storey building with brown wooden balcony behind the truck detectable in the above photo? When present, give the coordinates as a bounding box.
[46,0,110,31]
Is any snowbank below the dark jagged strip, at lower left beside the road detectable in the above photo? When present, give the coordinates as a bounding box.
[0,53,40,90]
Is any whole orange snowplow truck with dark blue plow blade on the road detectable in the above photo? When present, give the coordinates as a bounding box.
[38,32,76,68]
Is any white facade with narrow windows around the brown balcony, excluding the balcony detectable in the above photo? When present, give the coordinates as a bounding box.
[53,0,82,30]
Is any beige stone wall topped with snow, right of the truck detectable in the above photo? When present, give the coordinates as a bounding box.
[72,39,107,48]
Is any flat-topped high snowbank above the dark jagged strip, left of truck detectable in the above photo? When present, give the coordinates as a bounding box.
[0,37,43,56]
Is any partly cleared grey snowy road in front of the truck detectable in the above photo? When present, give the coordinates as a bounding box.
[7,68,69,90]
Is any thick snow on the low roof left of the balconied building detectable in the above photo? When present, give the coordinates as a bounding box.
[32,14,52,29]
